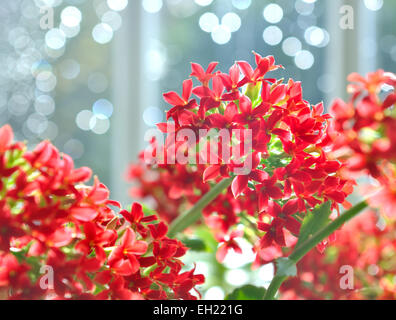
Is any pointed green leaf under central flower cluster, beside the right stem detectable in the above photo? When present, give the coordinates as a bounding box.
[295,201,331,248]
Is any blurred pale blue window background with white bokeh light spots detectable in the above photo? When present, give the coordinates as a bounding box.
[0,0,396,298]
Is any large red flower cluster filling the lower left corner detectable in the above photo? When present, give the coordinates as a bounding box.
[0,125,204,299]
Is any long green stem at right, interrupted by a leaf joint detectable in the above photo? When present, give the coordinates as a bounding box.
[264,201,368,300]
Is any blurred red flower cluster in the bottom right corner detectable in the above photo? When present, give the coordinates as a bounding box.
[281,210,396,300]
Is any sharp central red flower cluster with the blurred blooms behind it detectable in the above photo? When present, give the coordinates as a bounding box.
[129,53,352,264]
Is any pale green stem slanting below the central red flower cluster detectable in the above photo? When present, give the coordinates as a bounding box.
[168,178,233,237]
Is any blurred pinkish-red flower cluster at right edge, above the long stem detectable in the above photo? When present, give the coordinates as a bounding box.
[329,70,396,217]
